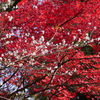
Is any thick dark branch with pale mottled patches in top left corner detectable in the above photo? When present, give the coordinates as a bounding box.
[0,0,21,12]
